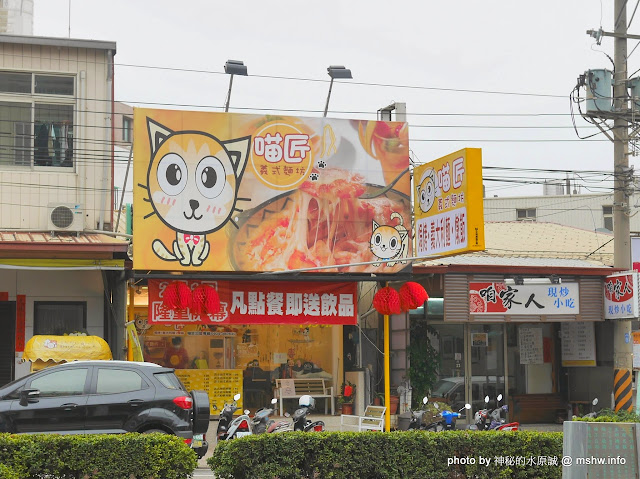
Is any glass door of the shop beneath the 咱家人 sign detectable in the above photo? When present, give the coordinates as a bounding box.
[467,324,507,412]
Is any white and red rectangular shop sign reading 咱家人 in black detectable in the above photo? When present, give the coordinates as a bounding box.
[469,282,580,315]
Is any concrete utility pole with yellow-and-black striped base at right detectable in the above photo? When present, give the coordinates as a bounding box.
[613,0,633,411]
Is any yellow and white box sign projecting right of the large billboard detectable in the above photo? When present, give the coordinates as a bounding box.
[413,148,484,257]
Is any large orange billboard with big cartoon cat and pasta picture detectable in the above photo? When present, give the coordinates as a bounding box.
[133,108,413,273]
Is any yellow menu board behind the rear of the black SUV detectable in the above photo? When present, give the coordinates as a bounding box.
[176,369,243,414]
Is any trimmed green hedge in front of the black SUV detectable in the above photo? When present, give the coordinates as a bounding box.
[0,433,198,479]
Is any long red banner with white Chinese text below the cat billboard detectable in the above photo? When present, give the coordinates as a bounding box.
[148,280,358,325]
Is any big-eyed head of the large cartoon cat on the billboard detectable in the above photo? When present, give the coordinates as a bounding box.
[147,118,251,234]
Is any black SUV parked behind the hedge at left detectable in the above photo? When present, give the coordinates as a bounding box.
[0,361,209,456]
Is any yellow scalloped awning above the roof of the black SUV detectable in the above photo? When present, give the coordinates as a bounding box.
[22,335,113,363]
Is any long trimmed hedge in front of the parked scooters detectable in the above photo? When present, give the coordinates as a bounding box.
[207,431,562,479]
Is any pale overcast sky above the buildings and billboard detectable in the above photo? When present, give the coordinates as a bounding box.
[34,0,640,197]
